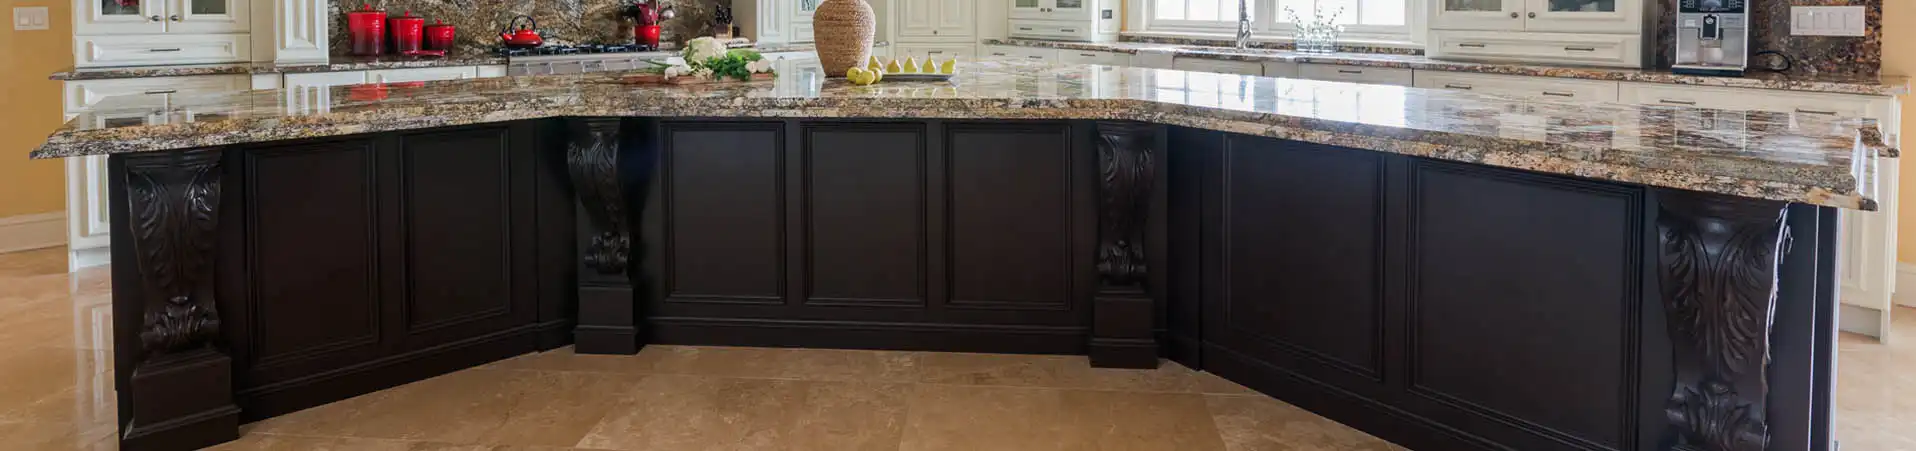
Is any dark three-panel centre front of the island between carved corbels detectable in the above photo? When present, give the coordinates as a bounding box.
[638,121,1096,353]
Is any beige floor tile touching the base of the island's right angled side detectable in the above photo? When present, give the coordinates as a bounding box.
[1205,395,1395,451]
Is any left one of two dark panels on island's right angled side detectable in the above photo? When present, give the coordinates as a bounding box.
[1203,132,1389,393]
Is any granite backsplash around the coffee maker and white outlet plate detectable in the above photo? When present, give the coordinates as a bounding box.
[1650,0,1905,77]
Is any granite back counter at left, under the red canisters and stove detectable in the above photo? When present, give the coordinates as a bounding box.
[48,42,869,81]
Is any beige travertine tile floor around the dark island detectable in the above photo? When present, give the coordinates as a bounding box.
[0,249,1916,451]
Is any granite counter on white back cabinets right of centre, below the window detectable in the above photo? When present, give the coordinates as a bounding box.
[985,38,1910,96]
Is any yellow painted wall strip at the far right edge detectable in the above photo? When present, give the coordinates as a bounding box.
[1883,0,1916,263]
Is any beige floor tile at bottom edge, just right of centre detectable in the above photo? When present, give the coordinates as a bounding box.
[901,384,1224,451]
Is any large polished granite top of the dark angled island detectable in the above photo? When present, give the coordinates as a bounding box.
[33,61,1895,209]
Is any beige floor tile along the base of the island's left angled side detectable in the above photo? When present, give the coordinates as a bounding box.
[253,368,642,447]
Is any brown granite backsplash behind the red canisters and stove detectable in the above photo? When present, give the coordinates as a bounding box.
[328,0,730,56]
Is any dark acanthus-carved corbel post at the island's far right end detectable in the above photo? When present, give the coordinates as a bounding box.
[1657,190,1785,451]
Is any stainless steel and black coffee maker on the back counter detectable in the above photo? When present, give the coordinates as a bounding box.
[1671,0,1749,77]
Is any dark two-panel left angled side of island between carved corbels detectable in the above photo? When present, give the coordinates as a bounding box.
[199,123,573,418]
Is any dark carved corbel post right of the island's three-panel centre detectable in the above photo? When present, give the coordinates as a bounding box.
[1088,123,1159,368]
